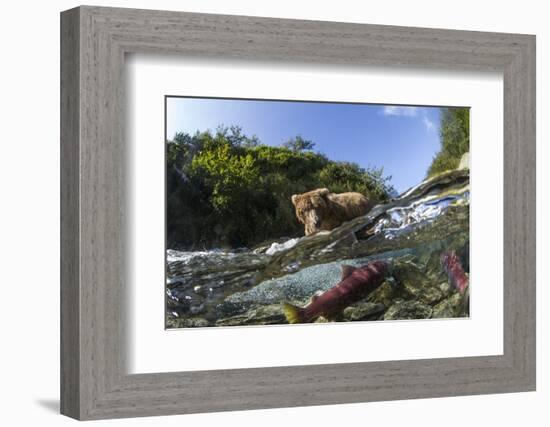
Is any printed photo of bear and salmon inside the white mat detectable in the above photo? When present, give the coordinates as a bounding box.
[165,97,470,329]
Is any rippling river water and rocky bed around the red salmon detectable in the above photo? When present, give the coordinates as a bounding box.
[166,168,470,328]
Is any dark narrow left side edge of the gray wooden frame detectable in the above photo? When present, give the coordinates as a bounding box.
[60,10,80,417]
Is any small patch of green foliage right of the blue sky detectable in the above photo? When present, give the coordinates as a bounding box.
[427,108,470,177]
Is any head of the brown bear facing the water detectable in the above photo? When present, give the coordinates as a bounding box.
[292,188,330,236]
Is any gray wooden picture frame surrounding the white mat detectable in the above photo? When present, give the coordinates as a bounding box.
[61,6,535,420]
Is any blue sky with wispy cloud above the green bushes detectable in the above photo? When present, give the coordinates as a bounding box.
[166,97,446,193]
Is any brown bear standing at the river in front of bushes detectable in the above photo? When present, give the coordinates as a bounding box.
[292,188,374,236]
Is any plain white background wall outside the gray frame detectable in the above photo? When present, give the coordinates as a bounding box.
[0,0,550,427]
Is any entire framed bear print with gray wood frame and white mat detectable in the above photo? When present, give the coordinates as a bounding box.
[61,6,535,419]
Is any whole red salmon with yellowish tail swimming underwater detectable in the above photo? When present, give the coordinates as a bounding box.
[283,261,389,323]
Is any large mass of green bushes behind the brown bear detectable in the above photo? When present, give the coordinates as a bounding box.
[166,126,394,250]
